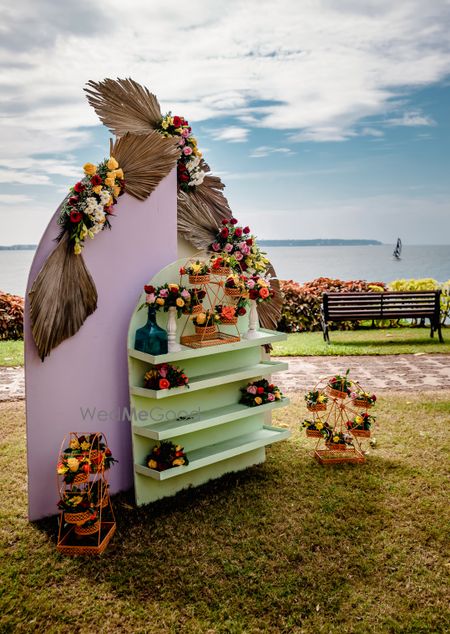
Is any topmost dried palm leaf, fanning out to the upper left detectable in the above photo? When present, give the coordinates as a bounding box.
[84,79,162,137]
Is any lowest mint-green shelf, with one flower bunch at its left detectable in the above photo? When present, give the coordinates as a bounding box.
[134,425,291,480]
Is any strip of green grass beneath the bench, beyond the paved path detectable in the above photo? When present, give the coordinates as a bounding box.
[272,328,450,357]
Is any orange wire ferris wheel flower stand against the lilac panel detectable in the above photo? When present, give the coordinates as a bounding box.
[56,432,116,555]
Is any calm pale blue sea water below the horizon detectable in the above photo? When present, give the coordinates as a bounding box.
[0,244,450,296]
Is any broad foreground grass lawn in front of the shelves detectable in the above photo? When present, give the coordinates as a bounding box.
[0,392,450,634]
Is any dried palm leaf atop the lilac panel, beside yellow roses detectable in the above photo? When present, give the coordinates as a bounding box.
[111,132,180,200]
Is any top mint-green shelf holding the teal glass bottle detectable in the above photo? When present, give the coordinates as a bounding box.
[128,328,286,365]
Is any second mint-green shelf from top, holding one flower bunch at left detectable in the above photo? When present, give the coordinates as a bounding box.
[130,358,289,399]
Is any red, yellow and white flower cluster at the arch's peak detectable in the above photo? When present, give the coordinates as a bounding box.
[156,112,206,192]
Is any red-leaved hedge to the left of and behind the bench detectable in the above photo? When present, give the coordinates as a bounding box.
[278,277,386,332]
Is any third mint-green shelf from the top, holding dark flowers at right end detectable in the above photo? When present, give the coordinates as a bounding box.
[133,398,289,440]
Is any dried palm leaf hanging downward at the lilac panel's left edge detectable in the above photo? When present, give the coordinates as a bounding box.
[29,234,97,361]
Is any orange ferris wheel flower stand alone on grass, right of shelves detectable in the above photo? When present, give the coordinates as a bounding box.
[304,371,376,465]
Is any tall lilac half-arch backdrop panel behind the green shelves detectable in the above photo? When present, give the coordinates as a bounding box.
[25,170,177,520]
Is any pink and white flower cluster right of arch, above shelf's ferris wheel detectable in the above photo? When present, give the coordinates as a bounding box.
[210,218,269,274]
